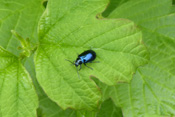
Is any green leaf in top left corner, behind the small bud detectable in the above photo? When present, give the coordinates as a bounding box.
[0,0,43,55]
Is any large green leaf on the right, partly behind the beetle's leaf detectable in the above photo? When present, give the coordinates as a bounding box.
[103,0,175,117]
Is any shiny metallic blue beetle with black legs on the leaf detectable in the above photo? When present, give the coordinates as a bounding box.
[67,50,98,77]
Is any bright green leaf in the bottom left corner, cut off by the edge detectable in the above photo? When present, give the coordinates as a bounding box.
[0,47,38,117]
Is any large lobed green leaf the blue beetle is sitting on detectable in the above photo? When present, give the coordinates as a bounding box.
[35,0,148,110]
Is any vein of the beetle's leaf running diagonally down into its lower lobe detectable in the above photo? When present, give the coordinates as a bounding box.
[40,46,97,108]
